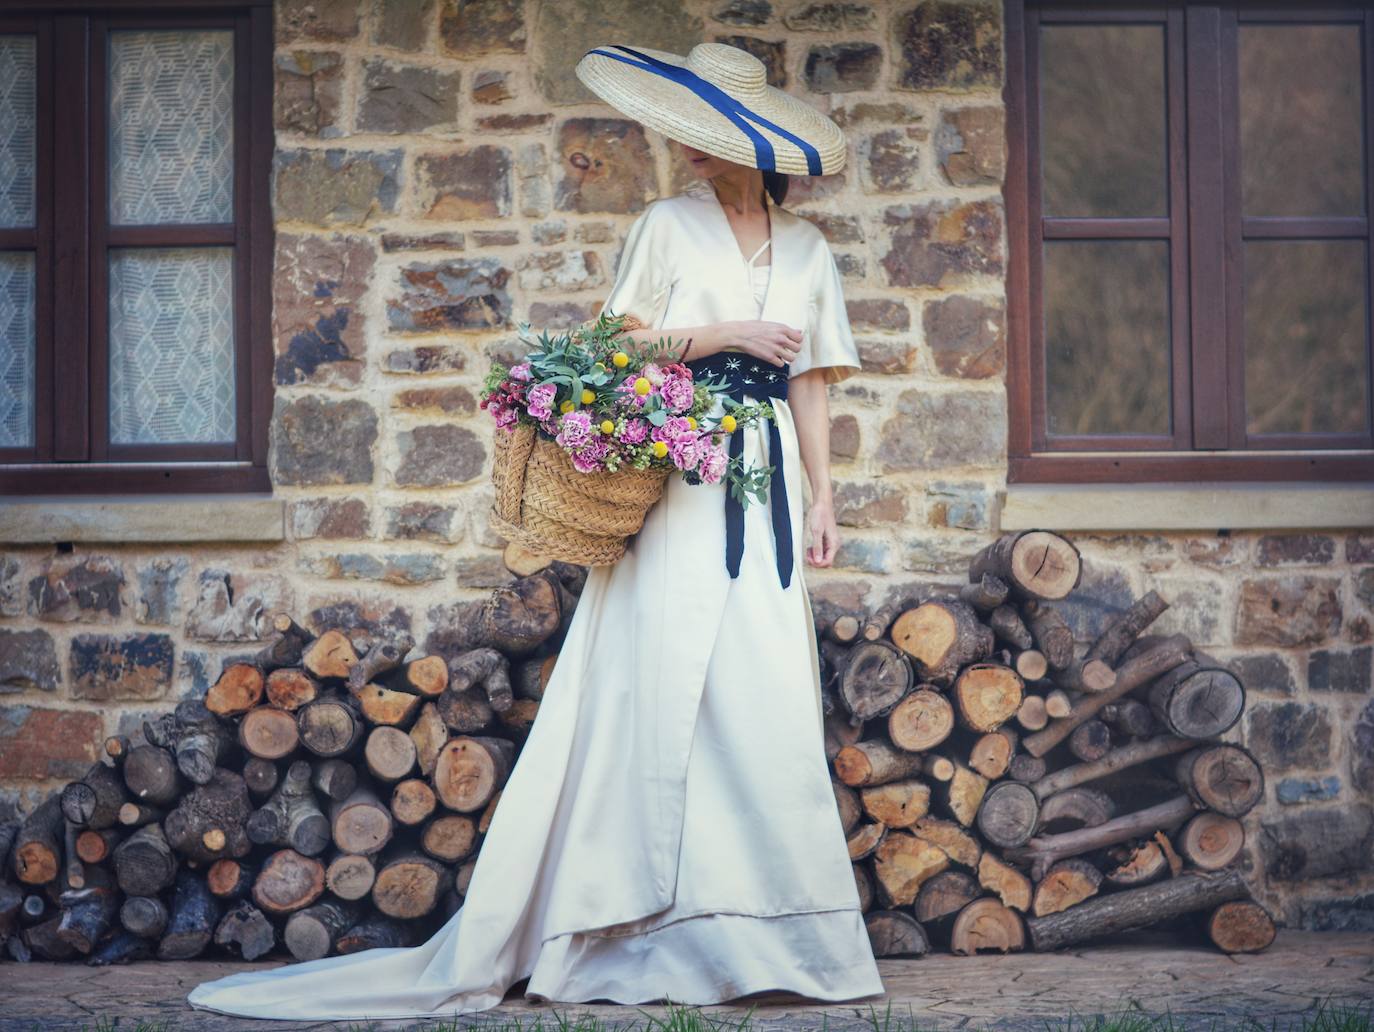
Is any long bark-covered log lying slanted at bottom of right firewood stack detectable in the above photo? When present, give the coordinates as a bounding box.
[1026,867,1248,950]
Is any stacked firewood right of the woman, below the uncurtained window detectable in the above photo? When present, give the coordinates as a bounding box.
[820,530,1274,956]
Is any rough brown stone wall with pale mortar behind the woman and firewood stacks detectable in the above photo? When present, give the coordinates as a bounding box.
[0,0,1374,928]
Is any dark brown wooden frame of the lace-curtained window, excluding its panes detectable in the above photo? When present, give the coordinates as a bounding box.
[0,0,273,496]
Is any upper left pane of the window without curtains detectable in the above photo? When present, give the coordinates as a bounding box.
[1040,25,1168,217]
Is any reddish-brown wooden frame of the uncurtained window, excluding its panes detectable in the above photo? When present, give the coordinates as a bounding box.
[1003,0,1374,484]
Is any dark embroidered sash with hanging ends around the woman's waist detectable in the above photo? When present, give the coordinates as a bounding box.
[687,352,793,588]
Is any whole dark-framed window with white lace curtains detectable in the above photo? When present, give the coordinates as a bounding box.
[0,3,272,495]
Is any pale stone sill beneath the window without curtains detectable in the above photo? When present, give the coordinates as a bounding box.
[1000,484,1374,530]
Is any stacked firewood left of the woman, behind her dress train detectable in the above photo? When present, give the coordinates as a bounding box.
[0,557,587,965]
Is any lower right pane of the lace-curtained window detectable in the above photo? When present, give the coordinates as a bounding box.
[110,247,234,444]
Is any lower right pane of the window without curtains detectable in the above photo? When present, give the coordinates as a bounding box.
[1245,240,1369,434]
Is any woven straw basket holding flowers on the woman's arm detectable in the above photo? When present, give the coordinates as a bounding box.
[492,425,669,566]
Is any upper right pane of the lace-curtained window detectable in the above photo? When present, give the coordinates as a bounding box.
[110,32,234,225]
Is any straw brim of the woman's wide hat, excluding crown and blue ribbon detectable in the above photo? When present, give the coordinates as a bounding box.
[574,47,845,176]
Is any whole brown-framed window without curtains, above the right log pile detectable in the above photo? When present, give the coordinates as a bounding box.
[1006,0,1374,482]
